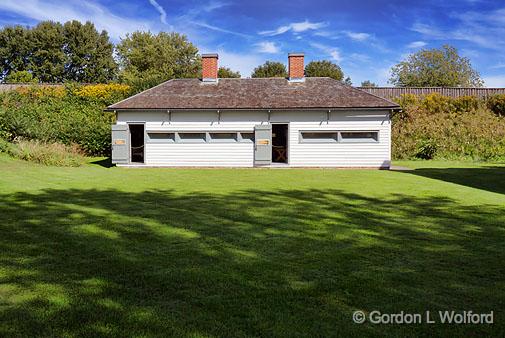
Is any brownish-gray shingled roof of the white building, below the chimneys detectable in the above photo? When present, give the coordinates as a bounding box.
[107,77,398,110]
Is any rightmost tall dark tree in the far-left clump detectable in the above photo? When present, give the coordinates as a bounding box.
[63,20,117,82]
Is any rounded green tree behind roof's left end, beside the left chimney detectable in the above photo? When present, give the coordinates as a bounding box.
[116,31,201,91]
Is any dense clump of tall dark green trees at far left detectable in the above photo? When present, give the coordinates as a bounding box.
[0,21,117,82]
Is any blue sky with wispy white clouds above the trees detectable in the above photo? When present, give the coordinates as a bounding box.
[0,0,505,87]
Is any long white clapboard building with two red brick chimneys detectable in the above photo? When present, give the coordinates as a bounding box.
[107,53,399,168]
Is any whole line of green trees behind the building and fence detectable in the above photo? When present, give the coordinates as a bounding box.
[0,20,483,91]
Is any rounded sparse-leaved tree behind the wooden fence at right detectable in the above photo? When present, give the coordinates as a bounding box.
[389,45,483,87]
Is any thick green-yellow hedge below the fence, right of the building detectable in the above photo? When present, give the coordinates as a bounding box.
[392,93,505,161]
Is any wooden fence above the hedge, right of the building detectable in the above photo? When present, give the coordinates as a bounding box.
[356,87,505,99]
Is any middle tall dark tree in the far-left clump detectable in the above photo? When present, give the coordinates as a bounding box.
[28,21,66,82]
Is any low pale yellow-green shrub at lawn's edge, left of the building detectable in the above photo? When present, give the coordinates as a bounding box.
[8,140,86,167]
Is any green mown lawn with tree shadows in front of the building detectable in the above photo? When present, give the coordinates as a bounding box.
[0,156,505,337]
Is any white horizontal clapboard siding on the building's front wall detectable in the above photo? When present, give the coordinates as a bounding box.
[117,111,390,167]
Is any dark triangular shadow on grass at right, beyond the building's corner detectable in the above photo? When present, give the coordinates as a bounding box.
[403,166,505,194]
